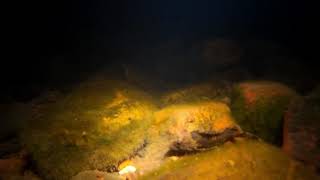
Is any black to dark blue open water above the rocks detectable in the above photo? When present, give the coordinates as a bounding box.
[0,0,318,100]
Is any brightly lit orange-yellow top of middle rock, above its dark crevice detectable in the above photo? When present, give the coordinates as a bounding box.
[154,101,236,135]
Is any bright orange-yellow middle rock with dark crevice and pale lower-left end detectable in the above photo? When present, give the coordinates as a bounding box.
[126,101,242,174]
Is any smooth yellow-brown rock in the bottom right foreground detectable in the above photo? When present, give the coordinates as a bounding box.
[140,138,319,180]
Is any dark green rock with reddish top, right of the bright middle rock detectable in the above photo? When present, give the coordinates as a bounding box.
[231,81,297,145]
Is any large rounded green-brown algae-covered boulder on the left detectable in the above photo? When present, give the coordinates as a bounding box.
[21,79,155,180]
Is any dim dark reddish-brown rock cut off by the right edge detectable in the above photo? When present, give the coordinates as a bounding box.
[283,87,320,171]
